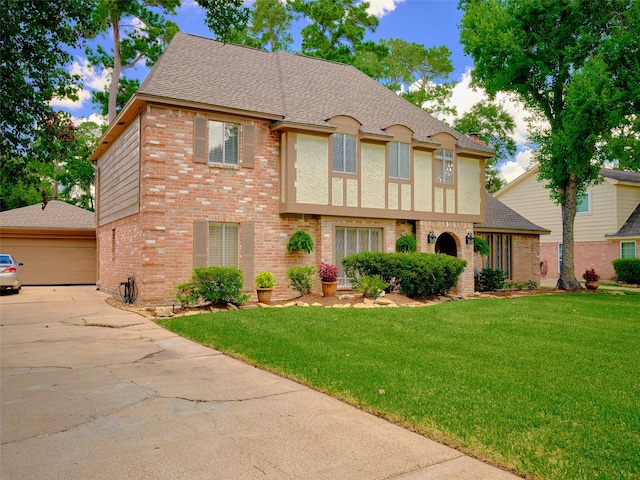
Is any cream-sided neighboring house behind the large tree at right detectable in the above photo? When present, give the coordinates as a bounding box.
[495,168,640,279]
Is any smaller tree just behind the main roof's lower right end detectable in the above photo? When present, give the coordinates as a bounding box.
[453,101,518,193]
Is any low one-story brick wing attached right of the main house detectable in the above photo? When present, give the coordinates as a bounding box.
[474,193,551,283]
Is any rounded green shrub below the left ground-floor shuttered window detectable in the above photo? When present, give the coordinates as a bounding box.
[175,267,251,306]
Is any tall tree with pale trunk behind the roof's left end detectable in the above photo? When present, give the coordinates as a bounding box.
[87,0,180,123]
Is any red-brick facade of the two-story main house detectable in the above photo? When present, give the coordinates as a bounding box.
[98,105,480,304]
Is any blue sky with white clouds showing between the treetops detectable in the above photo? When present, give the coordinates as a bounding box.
[54,0,530,181]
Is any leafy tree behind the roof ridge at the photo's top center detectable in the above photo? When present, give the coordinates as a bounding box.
[291,0,378,65]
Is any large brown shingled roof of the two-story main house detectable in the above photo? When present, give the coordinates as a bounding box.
[138,33,493,153]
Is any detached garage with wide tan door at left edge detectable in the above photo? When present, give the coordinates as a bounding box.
[0,200,97,285]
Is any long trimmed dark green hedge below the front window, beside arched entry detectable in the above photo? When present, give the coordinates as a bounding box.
[342,252,467,298]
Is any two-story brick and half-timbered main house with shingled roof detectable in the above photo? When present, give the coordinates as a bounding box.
[91,33,493,303]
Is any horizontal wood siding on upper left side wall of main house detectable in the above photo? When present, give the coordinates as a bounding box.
[98,119,140,225]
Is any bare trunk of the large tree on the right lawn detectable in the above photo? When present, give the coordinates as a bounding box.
[556,173,582,290]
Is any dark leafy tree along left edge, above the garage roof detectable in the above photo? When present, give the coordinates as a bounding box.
[0,0,93,199]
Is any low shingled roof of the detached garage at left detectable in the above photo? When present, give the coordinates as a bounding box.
[0,200,96,230]
